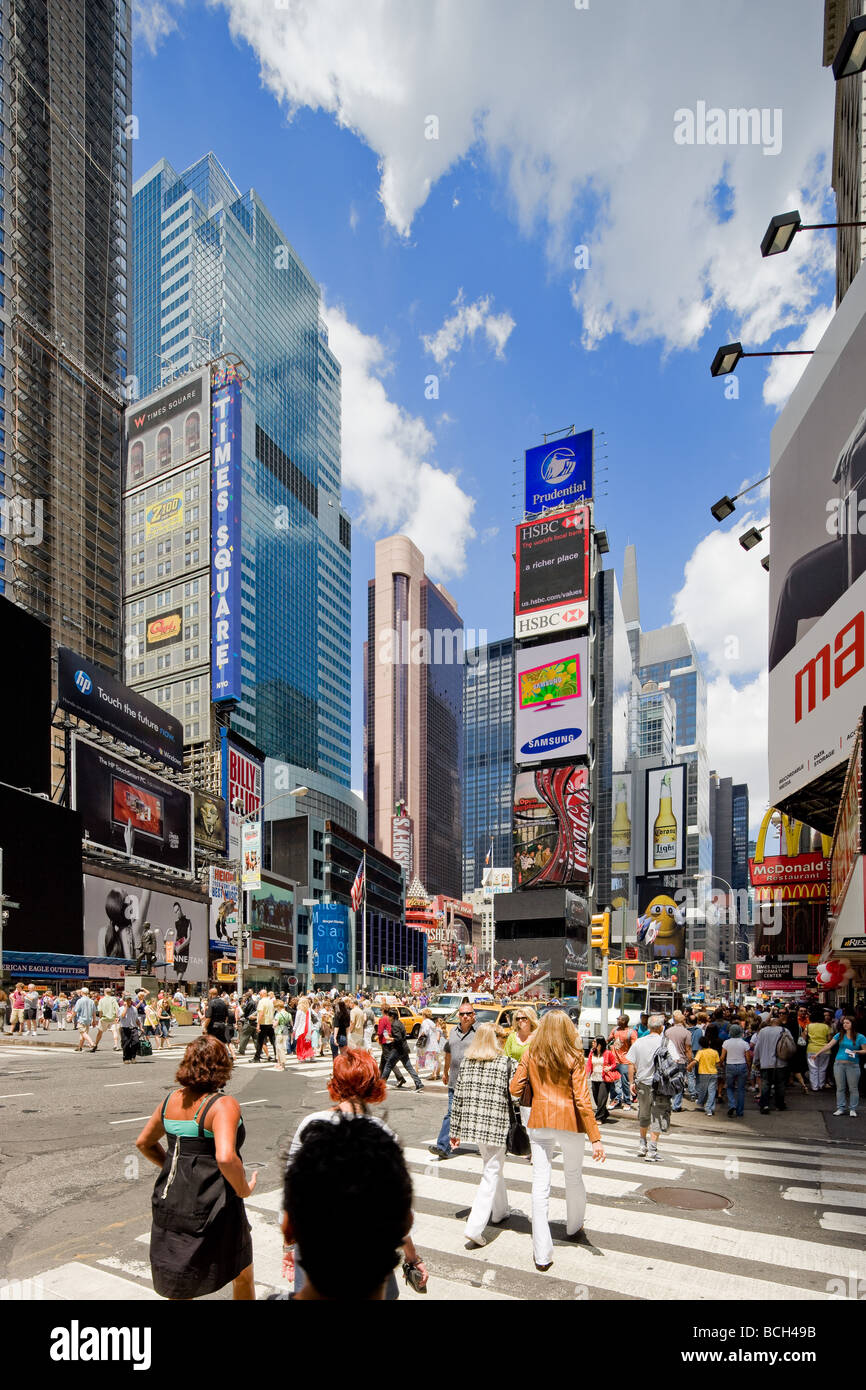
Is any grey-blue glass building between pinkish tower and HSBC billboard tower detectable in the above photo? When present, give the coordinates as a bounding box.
[463,637,514,898]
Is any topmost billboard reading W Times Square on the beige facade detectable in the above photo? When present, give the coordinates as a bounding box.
[125,371,210,488]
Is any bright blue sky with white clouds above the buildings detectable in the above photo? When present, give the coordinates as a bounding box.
[133,0,834,824]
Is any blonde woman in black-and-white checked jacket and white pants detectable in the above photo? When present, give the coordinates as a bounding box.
[450,1023,514,1245]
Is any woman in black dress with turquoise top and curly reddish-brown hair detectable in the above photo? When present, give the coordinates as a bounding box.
[136,1036,257,1300]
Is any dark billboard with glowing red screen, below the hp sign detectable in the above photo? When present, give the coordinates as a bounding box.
[72,734,193,873]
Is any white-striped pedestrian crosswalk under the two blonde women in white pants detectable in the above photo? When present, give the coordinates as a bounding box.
[0,1112,866,1301]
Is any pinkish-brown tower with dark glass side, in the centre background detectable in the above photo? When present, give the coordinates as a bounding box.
[364,535,464,897]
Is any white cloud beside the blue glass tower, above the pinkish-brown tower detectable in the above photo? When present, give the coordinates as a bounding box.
[322,307,475,578]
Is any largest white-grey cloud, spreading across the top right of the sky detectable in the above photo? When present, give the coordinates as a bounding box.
[210,0,834,348]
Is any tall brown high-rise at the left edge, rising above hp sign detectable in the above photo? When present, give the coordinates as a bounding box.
[0,0,133,673]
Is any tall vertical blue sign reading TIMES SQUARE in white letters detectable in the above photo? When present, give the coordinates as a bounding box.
[210,378,242,703]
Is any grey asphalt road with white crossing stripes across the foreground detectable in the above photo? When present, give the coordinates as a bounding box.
[0,1030,866,1302]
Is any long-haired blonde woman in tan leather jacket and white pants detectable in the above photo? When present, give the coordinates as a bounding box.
[510,1011,605,1269]
